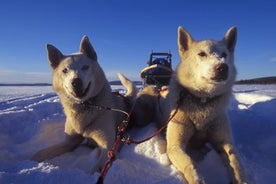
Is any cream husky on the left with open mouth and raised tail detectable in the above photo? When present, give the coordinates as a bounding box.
[33,36,136,172]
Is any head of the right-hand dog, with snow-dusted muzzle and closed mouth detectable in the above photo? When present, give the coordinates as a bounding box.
[176,27,237,97]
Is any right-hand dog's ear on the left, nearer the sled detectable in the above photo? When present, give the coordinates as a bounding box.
[178,26,193,54]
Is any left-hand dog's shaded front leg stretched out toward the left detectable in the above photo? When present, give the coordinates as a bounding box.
[31,135,83,162]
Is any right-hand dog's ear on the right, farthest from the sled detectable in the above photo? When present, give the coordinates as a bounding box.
[223,26,237,52]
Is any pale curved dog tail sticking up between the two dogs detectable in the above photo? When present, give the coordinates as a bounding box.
[117,73,138,100]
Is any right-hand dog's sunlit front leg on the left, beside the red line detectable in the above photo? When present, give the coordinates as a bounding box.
[167,118,205,184]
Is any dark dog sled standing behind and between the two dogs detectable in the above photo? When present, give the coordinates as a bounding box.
[140,52,173,88]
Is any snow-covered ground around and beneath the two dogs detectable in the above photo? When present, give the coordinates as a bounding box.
[0,85,276,184]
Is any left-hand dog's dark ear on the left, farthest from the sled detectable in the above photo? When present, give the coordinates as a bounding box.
[46,44,64,69]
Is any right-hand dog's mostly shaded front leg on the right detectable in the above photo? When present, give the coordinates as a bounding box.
[210,117,248,184]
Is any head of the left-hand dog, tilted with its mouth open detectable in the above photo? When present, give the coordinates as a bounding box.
[46,36,104,102]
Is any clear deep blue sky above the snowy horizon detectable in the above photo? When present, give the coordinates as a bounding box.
[0,0,276,83]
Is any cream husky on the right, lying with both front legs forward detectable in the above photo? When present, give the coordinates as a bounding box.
[166,27,247,184]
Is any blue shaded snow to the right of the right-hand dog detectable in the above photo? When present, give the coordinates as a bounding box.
[228,99,276,183]
